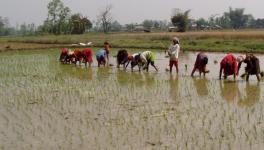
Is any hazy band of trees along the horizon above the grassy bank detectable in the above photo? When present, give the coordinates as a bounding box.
[0,0,264,36]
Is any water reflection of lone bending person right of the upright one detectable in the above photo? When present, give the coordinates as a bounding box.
[193,78,208,96]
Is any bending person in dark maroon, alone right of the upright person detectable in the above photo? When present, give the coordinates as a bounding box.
[191,52,209,77]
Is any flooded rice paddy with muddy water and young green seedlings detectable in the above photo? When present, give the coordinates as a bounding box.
[0,50,264,150]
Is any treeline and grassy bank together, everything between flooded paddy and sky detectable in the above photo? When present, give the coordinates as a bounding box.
[0,0,264,53]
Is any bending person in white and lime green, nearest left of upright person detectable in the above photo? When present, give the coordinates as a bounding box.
[140,51,158,72]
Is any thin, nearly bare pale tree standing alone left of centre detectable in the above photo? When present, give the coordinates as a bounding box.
[98,5,113,33]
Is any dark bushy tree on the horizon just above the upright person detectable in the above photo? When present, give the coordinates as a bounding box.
[171,10,190,32]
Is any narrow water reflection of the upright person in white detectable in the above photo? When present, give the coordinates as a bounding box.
[169,74,179,101]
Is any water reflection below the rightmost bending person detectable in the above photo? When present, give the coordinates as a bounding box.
[238,83,260,107]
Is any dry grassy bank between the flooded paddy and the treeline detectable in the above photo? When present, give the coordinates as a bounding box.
[0,30,264,53]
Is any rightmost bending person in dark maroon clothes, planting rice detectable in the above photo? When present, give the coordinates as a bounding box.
[237,54,261,81]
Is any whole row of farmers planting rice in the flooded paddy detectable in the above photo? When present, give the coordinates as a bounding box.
[60,37,261,81]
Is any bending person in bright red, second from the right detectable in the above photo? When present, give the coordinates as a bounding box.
[219,54,237,80]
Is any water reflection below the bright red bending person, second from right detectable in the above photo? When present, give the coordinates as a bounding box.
[220,81,239,102]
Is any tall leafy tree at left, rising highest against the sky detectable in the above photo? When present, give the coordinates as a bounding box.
[44,0,70,34]
